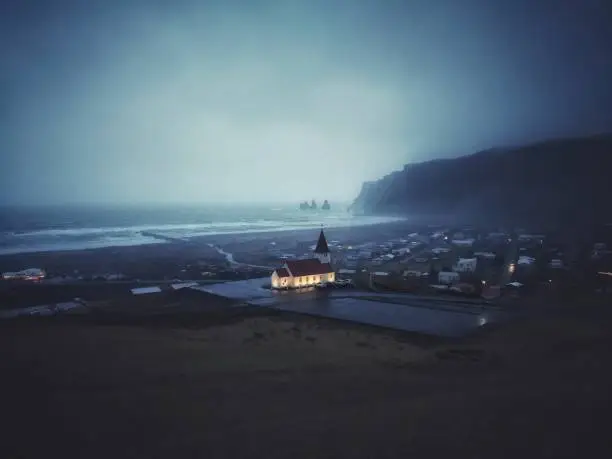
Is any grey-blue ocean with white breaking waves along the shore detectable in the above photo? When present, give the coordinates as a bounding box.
[0,205,397,255]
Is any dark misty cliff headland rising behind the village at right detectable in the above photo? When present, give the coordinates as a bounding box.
[351,135,612,225]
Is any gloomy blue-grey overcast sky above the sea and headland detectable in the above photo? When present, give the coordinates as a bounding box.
[0,0,612,204]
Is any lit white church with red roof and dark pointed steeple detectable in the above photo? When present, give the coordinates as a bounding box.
[272,230,336,288]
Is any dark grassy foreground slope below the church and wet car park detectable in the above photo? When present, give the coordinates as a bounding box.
[0,296,612,458]
